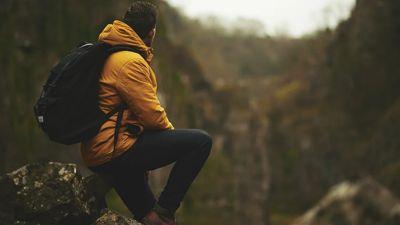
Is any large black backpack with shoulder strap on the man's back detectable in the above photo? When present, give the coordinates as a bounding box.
[34,42,141,148]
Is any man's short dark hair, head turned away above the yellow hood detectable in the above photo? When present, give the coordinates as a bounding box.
[123,1,157,39]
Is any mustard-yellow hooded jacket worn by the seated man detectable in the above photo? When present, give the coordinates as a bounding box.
[81,20,173,166]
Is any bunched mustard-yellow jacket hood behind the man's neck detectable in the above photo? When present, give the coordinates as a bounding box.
[99,20,153,62]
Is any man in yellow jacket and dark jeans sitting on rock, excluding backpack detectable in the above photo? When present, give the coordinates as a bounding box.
[81,1,212,225]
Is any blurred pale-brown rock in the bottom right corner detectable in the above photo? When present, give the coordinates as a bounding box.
[294,178,400,225]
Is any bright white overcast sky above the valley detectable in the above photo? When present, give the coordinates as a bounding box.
[167,0,355,36]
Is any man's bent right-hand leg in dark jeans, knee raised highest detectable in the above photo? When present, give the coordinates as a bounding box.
[120,129,212,218]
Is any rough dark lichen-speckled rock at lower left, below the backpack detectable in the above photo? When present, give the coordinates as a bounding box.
[0,162,112,225]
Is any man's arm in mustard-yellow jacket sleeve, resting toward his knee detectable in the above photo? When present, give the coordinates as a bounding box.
[116,60,174,130]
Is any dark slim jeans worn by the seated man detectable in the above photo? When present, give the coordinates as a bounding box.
[89,129,212,220]
